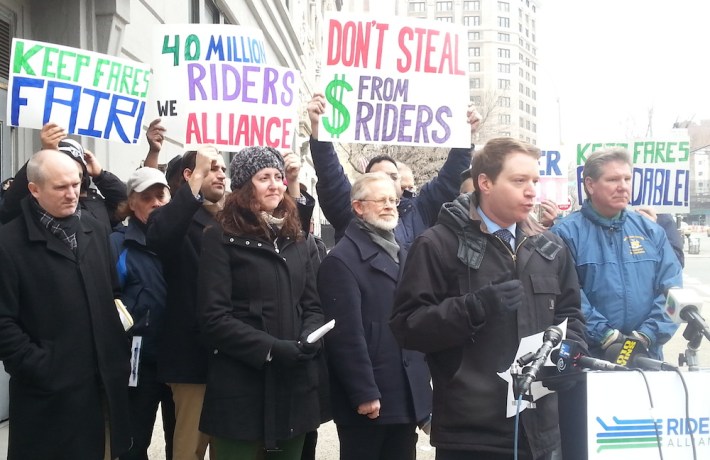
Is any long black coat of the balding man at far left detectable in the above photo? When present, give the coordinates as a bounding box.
[0,198,131,459]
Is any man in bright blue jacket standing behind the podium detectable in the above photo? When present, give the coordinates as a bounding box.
[552,148,683,360]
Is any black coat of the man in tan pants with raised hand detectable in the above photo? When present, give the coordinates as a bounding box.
[146,184,217,384]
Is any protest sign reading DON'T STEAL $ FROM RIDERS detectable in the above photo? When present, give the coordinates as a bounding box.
[318,14,471,147]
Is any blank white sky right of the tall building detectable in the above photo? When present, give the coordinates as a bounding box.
[537,0,710,148]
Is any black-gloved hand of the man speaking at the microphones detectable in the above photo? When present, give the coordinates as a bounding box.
[465,279,525,324]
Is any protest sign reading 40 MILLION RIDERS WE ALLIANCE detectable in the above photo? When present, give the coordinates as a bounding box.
[151,24,300,150]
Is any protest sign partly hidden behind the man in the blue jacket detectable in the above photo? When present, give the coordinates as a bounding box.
[575,139,690,213]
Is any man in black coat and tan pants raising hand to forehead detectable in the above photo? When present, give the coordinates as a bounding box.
[147,146,227,460]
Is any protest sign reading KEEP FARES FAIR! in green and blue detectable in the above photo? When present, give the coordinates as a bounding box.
[7,38,150,144]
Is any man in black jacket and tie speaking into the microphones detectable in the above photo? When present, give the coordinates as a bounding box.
[390,138,584,460]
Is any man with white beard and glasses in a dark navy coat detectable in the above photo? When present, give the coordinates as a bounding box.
[318,172,431,460]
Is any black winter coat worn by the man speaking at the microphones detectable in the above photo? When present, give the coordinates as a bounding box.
[390,194,584,458]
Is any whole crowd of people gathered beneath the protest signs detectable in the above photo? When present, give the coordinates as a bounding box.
[0,94,683,460]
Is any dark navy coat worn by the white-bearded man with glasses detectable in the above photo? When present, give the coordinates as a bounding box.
[318,221,431,425]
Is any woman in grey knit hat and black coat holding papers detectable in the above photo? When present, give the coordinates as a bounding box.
[198,147,323,460]
